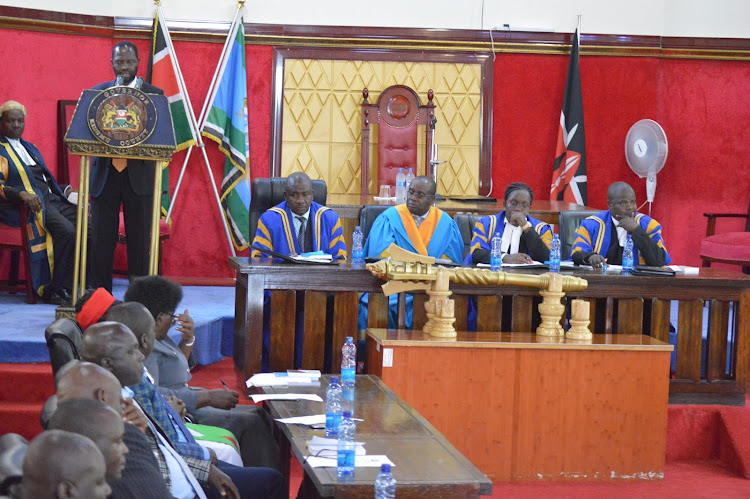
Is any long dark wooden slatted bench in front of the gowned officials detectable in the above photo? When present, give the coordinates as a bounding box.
[230,258,750,403]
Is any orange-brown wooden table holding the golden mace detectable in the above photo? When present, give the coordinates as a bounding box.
[367,329,673,481]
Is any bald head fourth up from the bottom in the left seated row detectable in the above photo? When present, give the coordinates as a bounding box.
[80,322,148,386]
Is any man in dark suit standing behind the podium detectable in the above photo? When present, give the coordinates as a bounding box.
[90,41,164,291]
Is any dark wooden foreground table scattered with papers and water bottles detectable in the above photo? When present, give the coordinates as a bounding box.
[264,376,492,499]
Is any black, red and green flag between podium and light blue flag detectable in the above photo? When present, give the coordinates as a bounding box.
[146,12,195,216]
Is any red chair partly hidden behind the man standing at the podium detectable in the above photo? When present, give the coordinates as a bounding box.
[57,100,172,275]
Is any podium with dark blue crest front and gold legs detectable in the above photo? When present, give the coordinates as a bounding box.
[64,86,175,305]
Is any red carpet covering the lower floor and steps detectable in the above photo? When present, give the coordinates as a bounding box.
[0,359,750,499]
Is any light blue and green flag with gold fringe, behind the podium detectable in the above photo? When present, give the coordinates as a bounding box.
[202,18,250,250]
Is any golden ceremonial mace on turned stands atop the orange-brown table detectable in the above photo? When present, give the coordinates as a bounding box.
[367,244,588,338]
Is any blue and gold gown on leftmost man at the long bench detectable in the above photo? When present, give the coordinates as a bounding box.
[250,201,346,260]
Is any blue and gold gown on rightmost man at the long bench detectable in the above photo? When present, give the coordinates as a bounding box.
[570,210,672,265]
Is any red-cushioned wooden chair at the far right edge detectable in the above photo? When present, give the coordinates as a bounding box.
[701,202,750,274]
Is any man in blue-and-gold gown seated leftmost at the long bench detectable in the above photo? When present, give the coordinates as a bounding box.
[250,172,346,371]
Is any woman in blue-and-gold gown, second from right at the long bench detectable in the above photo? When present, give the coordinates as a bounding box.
[464,182,552,266]
